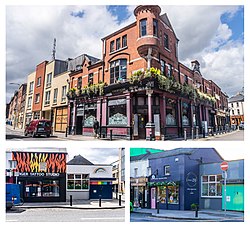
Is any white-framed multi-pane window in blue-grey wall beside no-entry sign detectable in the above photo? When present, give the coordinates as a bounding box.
[201,174,222,197]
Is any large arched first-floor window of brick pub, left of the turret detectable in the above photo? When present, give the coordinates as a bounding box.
[110,59,127,84]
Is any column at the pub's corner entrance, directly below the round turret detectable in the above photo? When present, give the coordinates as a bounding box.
[146,89,155,140]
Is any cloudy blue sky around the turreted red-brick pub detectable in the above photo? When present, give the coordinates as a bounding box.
[6,5,244,102]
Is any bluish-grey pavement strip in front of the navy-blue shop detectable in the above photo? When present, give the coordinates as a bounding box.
[133,208,244,222]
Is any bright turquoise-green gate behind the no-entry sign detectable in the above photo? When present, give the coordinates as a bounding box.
[222,184,244,211]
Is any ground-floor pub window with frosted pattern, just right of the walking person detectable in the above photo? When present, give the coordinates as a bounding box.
[108,99,128,126]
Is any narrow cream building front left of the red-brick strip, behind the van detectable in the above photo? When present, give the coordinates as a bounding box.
[24,71,36,125]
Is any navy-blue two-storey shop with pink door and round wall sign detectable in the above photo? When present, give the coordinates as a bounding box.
[148,148,222,210]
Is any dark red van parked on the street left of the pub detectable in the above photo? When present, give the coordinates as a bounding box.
[24,120,51,137]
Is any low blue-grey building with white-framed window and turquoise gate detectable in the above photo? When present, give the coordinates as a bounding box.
[199,160,244,211]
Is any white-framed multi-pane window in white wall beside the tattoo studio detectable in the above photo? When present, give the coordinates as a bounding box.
[67,174,89,190]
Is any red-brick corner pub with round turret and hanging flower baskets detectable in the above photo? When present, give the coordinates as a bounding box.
[68,5,228,140]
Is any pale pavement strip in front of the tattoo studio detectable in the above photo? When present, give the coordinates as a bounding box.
[15,199,125,209]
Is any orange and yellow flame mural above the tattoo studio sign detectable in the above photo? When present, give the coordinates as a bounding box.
[12,152,66,173]
